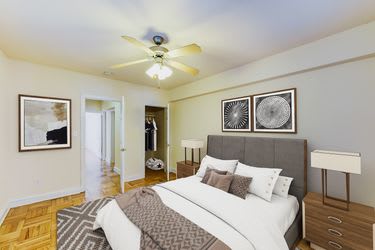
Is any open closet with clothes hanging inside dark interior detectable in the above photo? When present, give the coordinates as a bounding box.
[145,106,168,182]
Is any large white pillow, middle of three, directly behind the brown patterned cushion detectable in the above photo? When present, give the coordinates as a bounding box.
[235,162,282,201]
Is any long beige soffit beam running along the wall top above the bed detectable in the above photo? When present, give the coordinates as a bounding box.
[169,21,375,101]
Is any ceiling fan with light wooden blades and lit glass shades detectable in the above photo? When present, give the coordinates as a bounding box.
[111,35,202,80]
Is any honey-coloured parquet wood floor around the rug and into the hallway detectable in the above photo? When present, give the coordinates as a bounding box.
[0,159,310,250]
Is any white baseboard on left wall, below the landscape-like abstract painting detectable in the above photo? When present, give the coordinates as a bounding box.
[8,187,85,208]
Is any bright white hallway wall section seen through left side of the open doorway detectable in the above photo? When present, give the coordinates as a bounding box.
[85,112,102,159]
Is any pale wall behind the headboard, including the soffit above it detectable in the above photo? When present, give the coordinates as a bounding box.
[169,22,375,206]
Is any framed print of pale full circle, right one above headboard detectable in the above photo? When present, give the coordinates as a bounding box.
[253,88,297,133]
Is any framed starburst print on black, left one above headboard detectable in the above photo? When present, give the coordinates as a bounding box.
[221,97,251,132]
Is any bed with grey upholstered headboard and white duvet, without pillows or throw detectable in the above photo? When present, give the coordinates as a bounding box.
[94,135,307,250]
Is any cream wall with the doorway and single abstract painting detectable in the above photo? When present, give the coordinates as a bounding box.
[0,51,166,215]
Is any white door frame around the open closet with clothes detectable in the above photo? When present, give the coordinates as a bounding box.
[142,103,171,181]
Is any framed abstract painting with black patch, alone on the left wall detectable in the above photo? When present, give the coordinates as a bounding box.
[18,95,72,152]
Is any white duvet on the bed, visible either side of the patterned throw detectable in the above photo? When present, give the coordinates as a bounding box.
[94,176,298,250]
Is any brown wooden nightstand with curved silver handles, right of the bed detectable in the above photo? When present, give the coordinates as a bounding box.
[302,193,375,250]
